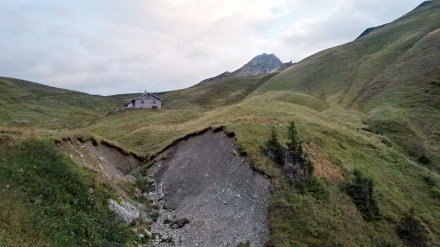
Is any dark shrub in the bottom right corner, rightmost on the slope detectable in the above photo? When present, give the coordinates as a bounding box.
[397,208,429,247]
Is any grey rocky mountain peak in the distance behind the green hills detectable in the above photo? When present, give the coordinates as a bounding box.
[198,53,292,85]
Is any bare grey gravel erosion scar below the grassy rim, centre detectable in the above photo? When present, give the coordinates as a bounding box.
[149,130,270,247]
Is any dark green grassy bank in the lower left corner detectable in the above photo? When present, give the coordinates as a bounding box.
[0,136,131,247]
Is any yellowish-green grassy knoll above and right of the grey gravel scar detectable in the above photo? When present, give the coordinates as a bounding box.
[83,92,440,246]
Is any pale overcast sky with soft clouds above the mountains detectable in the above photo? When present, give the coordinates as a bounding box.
[0,0,422,95]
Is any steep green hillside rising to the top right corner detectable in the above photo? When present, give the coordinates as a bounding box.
[254,1,440,171]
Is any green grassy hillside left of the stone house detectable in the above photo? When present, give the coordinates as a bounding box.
[0,77,123,128]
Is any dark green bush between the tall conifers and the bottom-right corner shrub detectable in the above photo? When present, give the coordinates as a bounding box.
[342,169,381,221]
